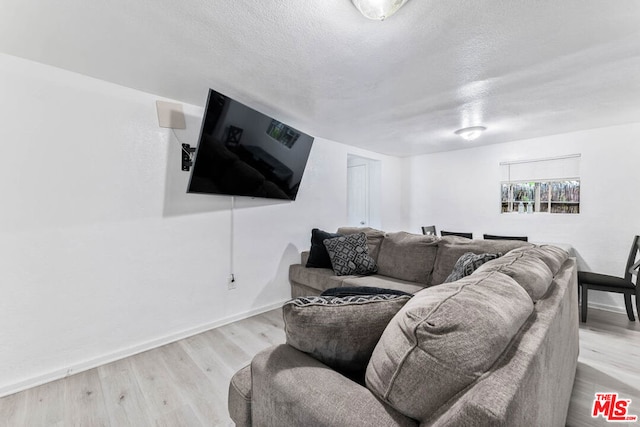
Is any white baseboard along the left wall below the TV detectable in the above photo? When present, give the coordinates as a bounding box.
[0,299,289,398]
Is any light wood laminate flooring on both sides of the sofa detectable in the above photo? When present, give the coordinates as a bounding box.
[0,309,640,427]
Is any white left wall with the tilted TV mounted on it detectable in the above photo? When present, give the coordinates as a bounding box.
[0,55,402,395]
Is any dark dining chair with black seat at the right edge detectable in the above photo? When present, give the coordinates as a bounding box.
[578,236,640,322]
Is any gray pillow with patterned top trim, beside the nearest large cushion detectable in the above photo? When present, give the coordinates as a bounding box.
[282,294,411,375]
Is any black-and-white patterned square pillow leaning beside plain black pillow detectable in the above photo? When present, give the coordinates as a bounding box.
[324,233,378,276]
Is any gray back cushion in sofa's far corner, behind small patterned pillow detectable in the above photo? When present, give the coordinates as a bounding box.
[429,236,533,285]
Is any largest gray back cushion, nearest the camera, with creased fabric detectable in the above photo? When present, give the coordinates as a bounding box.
[366,272,533,421]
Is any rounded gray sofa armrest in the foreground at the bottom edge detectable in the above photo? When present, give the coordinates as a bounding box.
[251,344,418,427]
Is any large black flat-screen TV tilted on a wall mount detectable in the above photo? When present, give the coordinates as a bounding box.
[187,89,313,200]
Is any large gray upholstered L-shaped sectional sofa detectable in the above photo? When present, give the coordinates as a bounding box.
[229,228,578,427]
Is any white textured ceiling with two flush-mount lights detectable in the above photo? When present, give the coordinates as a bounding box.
[0,0,640,156]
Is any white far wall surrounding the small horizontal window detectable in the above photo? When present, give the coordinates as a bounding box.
[404,123,640,308]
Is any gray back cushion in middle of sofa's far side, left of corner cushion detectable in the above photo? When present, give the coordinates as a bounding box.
[378,231,438,285]
